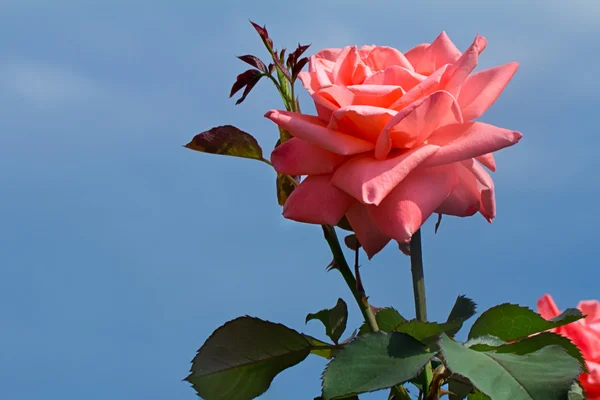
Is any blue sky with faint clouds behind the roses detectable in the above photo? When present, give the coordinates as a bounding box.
[0,0,600,400]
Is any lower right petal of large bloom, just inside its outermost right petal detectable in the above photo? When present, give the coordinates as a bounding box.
[435,163,481,217]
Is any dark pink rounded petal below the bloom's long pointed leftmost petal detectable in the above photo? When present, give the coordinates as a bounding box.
[271,138,346,175]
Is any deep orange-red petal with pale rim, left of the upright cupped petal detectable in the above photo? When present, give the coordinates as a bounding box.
[329,106,396,143]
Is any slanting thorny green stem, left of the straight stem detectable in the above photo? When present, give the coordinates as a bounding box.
[322,225,379,332]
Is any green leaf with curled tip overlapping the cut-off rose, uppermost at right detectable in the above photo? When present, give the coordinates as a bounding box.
[469,304,583,342]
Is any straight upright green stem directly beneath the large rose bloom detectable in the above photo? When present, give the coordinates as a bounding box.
[410,229,433,395]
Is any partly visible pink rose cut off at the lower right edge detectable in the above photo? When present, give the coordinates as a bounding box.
[537,294,600,400]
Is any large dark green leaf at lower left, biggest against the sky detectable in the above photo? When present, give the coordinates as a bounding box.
[185,317,311,400]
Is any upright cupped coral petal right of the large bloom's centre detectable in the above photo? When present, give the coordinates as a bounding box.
[375,91,462,160]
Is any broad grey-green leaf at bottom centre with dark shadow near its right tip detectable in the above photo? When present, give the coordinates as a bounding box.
[323,332,435,400]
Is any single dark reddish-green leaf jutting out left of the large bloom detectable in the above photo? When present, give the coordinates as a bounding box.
[185,125,268,163]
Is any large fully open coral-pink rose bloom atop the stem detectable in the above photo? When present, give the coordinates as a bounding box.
[265,32,522,258]
